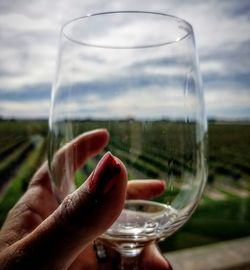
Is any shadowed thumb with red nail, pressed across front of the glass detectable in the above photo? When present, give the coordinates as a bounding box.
[1,152,127,269]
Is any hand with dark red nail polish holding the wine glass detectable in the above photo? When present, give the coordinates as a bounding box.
[0,130,171,270]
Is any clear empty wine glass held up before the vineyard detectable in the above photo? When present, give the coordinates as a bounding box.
[49,11,207,269]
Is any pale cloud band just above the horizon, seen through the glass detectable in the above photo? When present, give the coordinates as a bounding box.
[54,86,199,120]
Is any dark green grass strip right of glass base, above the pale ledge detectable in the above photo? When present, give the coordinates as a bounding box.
[160,198,250,251]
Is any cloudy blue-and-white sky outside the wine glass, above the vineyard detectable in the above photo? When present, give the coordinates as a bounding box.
[0,0,250,120]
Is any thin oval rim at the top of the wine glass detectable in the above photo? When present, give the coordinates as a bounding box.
[61,10,194,49]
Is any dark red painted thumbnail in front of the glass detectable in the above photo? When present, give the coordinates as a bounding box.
[88,152,121,195]
